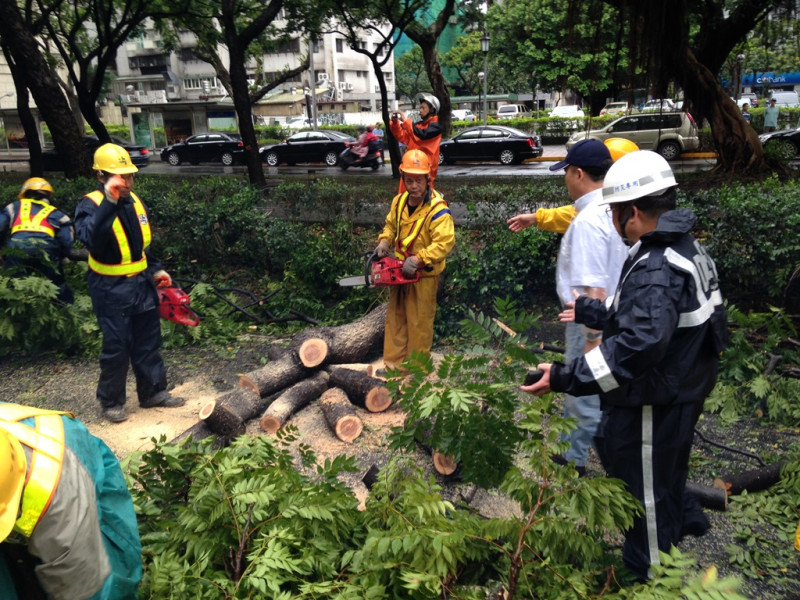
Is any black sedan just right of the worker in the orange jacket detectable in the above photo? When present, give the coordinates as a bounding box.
[439,125,543,165]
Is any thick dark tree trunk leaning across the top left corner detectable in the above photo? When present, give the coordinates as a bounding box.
[0,2,91,177]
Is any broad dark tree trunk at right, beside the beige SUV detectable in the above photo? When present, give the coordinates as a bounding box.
[678,49,770,173]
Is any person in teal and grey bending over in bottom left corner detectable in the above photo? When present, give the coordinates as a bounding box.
[0,403,142,600]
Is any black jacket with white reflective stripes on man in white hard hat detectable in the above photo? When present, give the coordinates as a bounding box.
[550,209,728,407]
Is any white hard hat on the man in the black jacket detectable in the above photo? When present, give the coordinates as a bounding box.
[603,150,678,204]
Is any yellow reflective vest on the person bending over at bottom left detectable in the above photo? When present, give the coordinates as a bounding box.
[0,404,73,538]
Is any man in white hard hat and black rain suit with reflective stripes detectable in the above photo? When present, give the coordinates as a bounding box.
[522,151,728,580]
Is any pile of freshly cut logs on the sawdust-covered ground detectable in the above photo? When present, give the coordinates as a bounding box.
[200,304,392,442]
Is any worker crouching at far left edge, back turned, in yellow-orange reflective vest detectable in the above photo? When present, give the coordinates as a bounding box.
[0,177,74,304]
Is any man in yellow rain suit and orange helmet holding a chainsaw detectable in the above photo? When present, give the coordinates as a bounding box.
[375,150,456,368]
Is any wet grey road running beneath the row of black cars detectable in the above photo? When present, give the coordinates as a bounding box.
[0,145,716,177]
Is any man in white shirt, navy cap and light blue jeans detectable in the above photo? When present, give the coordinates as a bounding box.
[550,140,627,475]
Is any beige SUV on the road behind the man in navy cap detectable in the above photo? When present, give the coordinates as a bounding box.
[567,112,700,160]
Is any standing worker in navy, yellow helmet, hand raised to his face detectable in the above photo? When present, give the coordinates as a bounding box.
[75,144,184,423]
